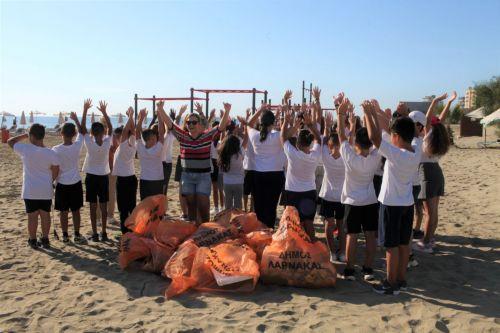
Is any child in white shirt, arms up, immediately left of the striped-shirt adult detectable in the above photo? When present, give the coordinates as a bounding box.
[135,109,165,200]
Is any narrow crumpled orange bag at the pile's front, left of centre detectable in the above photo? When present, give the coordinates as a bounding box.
[163,240,199,298]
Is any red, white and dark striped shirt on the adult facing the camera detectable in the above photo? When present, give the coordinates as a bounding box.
[172,124,219,173]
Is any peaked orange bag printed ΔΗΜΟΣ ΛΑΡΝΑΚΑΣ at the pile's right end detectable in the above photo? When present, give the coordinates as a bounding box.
[260,206,337,288]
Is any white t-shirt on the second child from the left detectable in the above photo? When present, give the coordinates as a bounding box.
[52,133,83,185]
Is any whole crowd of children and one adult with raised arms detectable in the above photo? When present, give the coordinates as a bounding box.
[8,88,456,294]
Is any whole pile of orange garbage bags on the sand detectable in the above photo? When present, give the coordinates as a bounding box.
[119,195,337,298]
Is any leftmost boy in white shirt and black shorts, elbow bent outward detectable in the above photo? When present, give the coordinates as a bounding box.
[7,124,59,249]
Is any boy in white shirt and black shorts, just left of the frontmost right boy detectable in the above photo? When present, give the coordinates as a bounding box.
[337,98,381,281]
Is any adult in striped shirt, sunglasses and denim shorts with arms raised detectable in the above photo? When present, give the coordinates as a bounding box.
[157,101,231,224]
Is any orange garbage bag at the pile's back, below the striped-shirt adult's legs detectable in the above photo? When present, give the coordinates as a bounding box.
[153,219,196,251]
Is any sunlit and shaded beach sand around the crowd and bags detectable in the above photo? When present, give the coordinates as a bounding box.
[0,126,500,332]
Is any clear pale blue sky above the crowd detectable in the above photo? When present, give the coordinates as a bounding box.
[0,0,500,114]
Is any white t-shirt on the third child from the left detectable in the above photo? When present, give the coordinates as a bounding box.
[82,134,112,176]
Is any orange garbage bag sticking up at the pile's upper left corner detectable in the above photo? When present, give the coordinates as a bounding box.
[125,194,165,238]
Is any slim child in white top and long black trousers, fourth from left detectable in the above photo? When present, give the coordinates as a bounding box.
[111,108,137,234]
